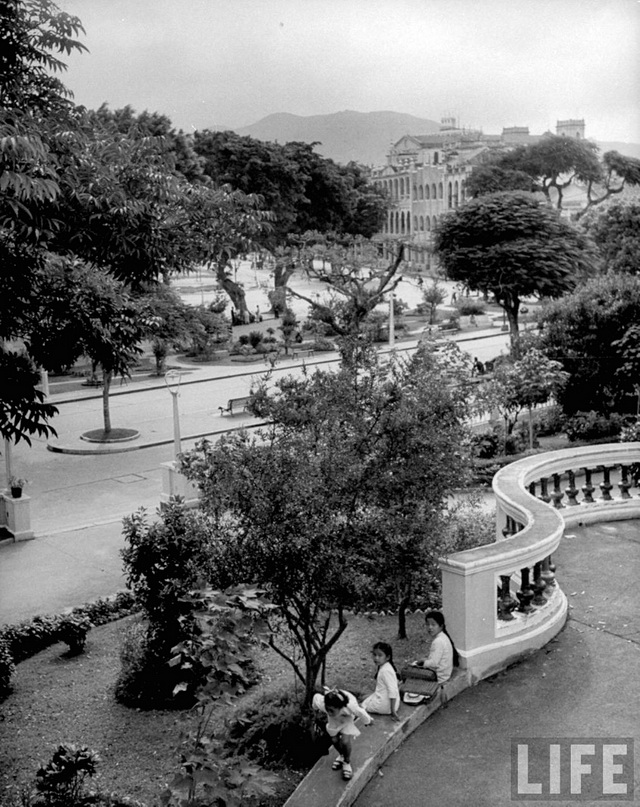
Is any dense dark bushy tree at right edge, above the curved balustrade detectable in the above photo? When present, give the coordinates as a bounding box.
[541,274,640,415]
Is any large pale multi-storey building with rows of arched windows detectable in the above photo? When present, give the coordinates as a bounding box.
[371,117,584,270]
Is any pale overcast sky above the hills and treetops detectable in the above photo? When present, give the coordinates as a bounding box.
[57,0,640,143]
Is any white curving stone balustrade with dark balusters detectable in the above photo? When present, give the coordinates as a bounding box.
[440,443,640,680]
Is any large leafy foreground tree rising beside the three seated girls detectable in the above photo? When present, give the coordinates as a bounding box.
[183,350,467,699]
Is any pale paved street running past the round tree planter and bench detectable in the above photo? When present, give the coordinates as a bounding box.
[7,326,505,534]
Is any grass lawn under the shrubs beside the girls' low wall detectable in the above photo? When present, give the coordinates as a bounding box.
[0,614,427,807]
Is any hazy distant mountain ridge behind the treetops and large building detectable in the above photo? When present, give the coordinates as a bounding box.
[204,110,640,165]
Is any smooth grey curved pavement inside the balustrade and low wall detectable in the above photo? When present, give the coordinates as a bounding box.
[355,521,640,807]
